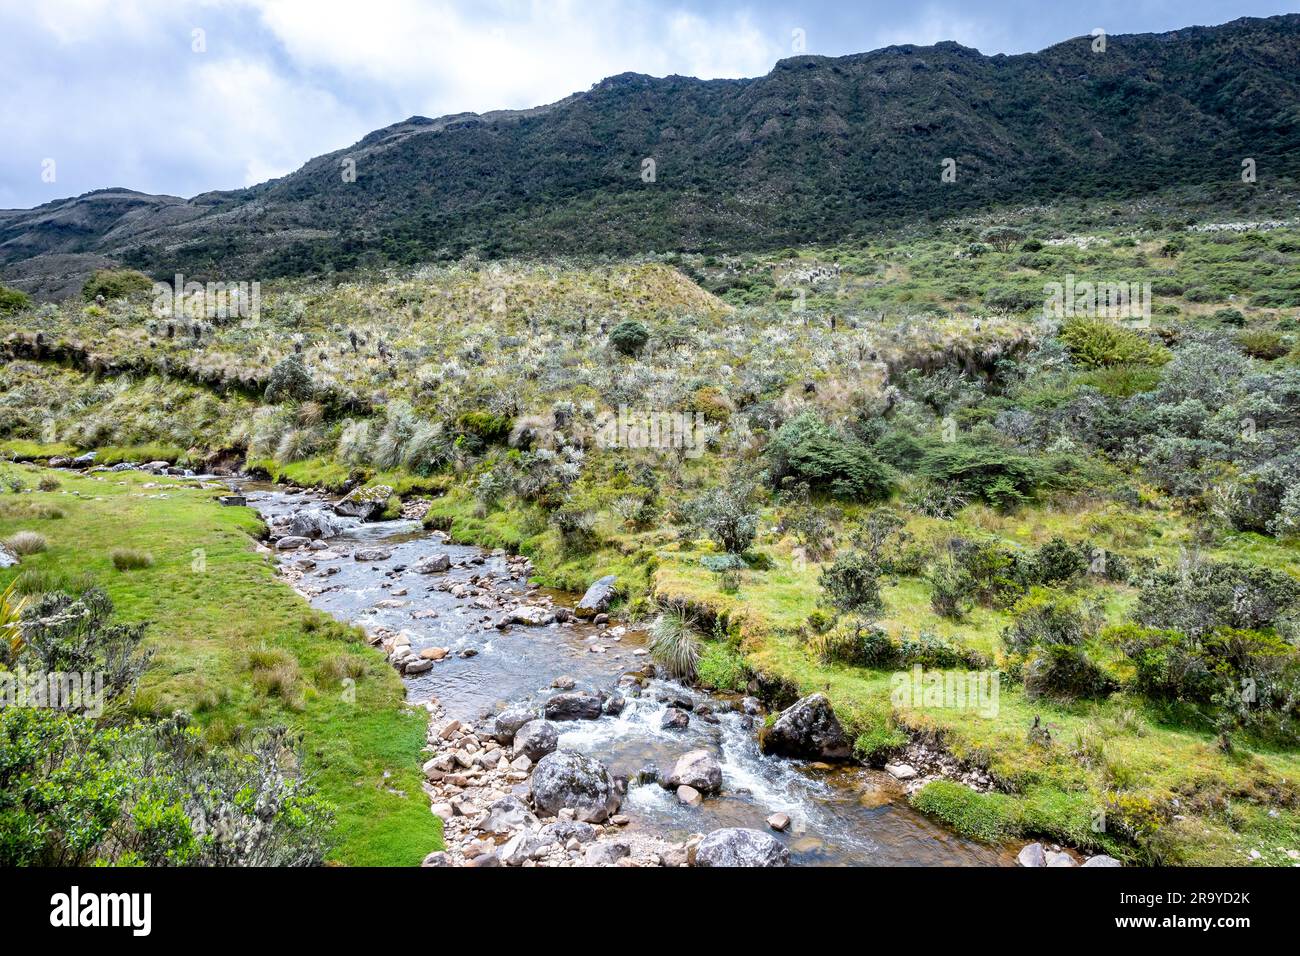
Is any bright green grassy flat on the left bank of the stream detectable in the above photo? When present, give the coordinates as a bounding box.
[0,468,441,865]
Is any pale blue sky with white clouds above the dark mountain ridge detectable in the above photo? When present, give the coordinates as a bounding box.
[0,0,1300,208]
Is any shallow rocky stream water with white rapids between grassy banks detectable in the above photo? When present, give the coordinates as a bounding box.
[248,485,1013,866]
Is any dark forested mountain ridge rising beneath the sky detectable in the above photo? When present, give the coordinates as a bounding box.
[0,14,1300,297]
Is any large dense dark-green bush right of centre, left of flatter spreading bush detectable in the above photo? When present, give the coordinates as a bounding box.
[767,412,892,501]
